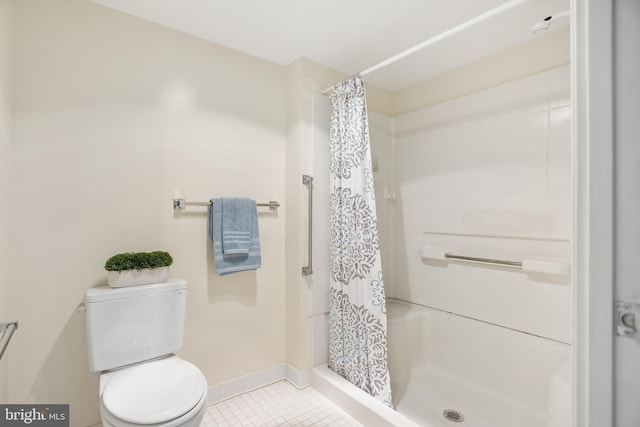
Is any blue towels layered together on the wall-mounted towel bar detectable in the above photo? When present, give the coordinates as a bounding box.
[209,197,262,276]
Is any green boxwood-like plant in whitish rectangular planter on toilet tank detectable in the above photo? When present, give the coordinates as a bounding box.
[104,251,173,288]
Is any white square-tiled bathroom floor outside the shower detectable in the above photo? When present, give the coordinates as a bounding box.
[200,381,362,427]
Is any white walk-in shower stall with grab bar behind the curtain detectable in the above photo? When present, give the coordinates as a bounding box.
[310,5,574,427]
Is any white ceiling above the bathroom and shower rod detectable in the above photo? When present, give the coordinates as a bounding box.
[91,0,570,92]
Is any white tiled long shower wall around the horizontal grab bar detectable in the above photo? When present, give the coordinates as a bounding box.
[383,66,573,342]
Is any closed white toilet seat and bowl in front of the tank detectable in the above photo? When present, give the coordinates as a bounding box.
[100,356,207,425]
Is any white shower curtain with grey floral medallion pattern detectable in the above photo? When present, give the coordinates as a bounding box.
[329,76,392,406]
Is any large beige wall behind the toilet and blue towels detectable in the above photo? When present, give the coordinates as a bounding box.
[11,0,287,425]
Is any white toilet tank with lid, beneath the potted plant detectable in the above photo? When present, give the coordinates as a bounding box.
[85,279,187,372]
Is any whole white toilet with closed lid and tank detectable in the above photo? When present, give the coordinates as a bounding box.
[85,279,207,427]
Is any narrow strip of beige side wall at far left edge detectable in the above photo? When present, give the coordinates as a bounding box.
[0,0,13,402]
